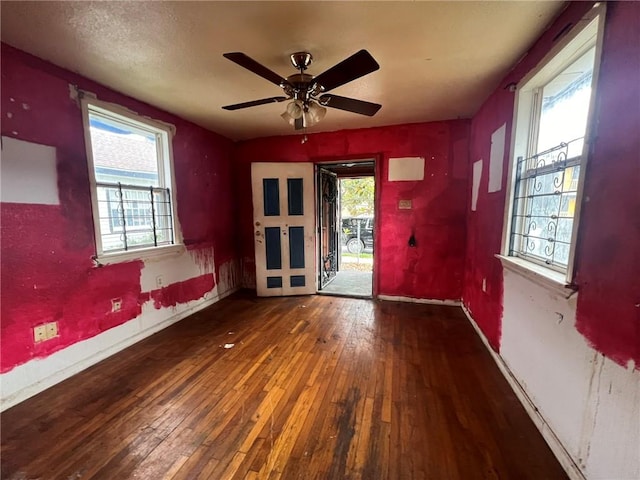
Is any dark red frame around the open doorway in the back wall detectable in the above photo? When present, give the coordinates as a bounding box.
[311,152,384,300]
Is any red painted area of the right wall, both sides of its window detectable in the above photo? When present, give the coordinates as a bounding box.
[463,2,640,366]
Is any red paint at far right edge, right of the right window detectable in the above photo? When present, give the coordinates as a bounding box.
[576,2,640,370]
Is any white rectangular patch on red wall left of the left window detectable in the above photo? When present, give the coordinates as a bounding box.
[0,137,60,205]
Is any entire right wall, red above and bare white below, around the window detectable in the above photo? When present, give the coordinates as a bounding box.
[463,2,640,480]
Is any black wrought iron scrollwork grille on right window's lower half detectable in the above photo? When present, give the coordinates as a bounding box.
[509,137,584,271]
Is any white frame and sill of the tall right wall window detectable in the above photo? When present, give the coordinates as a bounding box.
[497,3,605,297]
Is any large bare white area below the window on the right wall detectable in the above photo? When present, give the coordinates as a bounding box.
[500,269,640,479]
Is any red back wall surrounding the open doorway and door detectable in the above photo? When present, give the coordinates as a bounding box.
[235,120,468,300]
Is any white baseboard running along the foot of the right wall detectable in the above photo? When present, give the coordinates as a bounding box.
[461,304,586,480]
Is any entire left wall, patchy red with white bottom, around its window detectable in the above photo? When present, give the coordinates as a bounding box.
[0,44,240,409]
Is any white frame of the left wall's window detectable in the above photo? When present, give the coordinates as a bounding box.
[78,91,184,265]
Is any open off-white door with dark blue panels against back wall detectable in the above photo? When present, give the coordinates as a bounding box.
[251,163,316,297]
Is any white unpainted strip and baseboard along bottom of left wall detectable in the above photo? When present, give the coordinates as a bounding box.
[0,288,238,412]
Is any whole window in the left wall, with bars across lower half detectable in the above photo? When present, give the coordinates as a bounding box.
[83,98,177,256]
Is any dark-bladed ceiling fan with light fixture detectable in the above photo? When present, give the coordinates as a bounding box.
[222,50,382,130]
